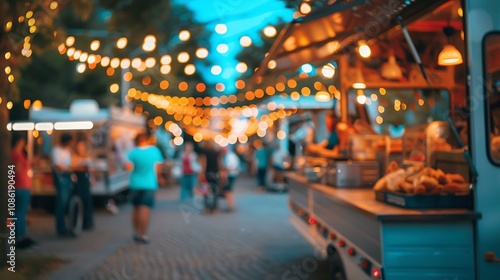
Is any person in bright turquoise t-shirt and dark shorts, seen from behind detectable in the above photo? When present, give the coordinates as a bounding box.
[126,133,164,244]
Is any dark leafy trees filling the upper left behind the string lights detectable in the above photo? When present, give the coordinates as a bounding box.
[0,0,215,265]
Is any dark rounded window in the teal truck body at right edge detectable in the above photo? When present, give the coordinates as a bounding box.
[483,32,500,164]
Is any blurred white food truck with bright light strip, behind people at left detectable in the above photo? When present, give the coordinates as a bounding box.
[11,100,146,207]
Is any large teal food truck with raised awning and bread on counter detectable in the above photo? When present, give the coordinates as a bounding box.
[255,0,500,280]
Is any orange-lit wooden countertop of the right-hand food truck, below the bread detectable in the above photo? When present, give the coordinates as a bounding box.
[286,172,481,222]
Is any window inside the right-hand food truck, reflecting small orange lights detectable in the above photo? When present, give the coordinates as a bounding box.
[348,88,450,137]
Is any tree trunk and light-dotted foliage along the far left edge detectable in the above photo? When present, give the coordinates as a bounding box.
[0,0,93,266]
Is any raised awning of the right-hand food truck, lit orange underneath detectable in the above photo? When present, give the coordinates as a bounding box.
[254,0,448,77]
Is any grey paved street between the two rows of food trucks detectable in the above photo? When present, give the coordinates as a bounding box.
[16,178,328,280]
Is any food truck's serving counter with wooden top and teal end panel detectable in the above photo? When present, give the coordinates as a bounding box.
[287,173,481,280]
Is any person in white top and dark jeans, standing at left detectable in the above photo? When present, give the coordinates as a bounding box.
[51,133,73,236]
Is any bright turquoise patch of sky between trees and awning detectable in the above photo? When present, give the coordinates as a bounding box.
[176,0,293,93]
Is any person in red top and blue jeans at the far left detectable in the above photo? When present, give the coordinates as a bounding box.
[11,133,36,249]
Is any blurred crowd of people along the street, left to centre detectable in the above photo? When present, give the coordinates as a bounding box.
[12,130,290,248]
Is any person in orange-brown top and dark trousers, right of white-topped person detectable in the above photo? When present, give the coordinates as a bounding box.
[73,141,94,230]
